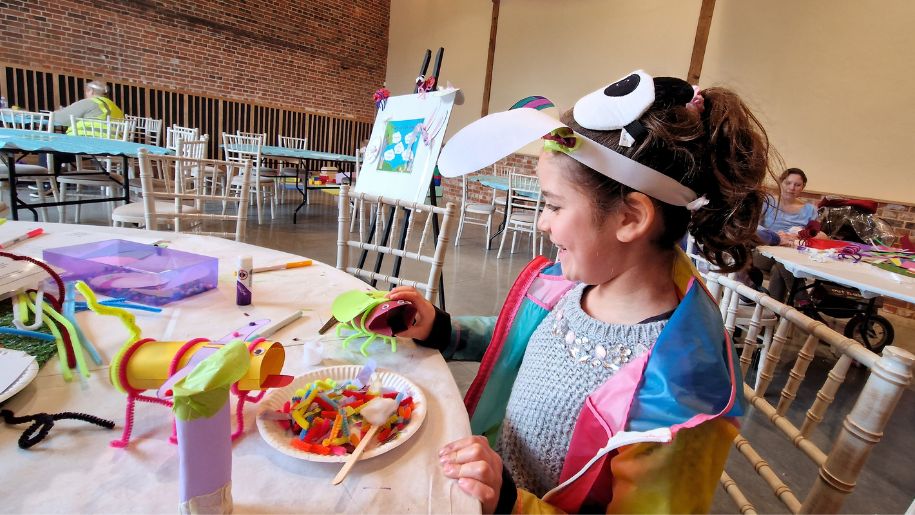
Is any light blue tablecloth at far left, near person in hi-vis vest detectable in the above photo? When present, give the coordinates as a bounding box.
[0,129,173,157]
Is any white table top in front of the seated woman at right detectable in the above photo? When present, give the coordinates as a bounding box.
[757,246,915,303]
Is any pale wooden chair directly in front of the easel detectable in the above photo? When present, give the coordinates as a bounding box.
[337,185,456,302]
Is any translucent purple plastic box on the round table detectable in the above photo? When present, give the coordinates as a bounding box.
[44,240,219,306]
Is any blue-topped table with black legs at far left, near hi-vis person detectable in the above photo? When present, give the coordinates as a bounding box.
[0,128,172,220]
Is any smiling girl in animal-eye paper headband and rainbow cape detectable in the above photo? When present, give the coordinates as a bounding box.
[389,71,768,513]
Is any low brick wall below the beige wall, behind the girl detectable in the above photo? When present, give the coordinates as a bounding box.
[442,154,915,319]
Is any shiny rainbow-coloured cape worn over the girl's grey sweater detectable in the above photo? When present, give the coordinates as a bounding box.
[464,252,743,513]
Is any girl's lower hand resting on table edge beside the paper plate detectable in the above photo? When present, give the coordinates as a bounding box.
[438,435,502,513]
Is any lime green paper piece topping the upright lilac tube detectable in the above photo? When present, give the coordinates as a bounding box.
[172,340,251,420]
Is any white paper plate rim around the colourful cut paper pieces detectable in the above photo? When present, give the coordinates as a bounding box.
[257,365,426,463]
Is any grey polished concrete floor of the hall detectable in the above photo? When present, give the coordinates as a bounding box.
[14,192,915,513]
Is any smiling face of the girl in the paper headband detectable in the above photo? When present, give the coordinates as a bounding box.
[537,151,621,285]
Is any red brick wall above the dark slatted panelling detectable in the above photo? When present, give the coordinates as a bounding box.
[0,0,390,120]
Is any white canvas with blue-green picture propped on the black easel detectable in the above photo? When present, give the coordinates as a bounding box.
[355,89,457,206]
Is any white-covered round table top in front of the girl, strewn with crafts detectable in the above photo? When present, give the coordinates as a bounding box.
[0,222,480,513]
